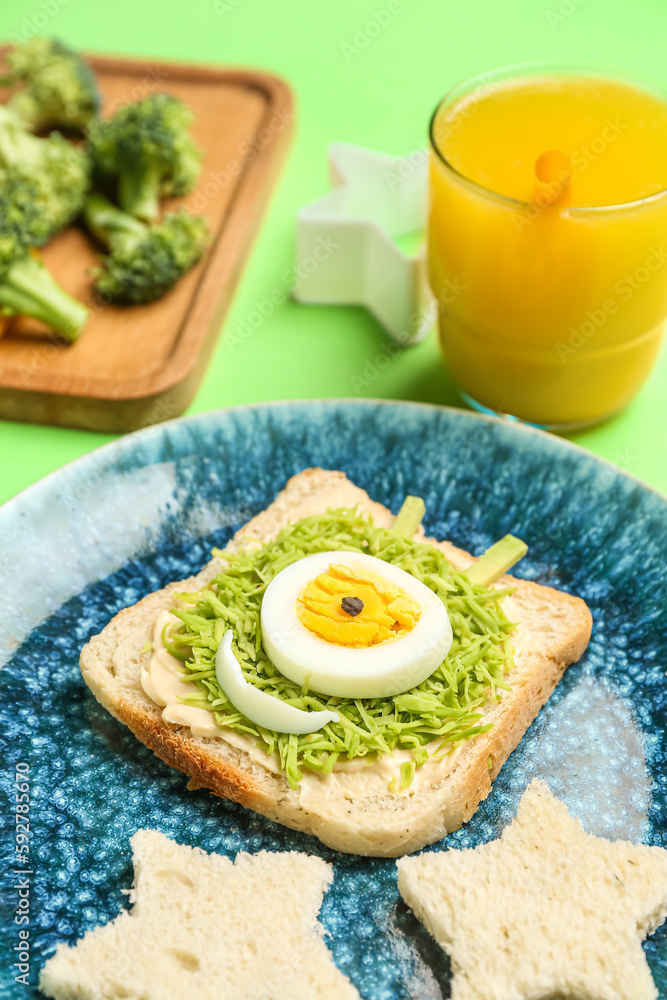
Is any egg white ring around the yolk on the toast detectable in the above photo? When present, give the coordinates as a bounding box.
[260,551,453,698]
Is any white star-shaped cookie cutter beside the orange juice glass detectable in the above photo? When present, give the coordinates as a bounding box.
[293,142,437,345]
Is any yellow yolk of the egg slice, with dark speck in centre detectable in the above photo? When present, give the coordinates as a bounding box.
[296,565,421,646]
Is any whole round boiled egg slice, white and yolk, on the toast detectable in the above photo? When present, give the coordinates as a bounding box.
[261,551,452,698]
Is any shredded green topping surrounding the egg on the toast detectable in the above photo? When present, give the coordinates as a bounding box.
[163,508,515,788]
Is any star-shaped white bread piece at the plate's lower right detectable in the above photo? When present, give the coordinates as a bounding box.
[397,781,667,1000]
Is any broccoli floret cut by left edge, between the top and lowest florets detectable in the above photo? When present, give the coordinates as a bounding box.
[0,105,90,239]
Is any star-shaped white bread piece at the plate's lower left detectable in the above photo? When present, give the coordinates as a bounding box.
[40,830,359,1000]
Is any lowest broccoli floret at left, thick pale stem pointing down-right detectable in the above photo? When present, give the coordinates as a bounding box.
[0,186,88,342]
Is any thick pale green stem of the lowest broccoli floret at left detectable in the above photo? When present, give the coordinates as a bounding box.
[0,254,88,343]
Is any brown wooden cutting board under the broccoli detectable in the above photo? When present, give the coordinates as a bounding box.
[0,48,293,431]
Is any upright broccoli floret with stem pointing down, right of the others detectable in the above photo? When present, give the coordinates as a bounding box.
[88,94,201,221]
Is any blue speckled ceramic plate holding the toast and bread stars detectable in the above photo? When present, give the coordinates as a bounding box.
[0,401,667,1000]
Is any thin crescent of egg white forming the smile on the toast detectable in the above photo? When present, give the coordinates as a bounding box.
[215,629,338,736]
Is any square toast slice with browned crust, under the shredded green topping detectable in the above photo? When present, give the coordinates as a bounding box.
[81,469,592,857]
